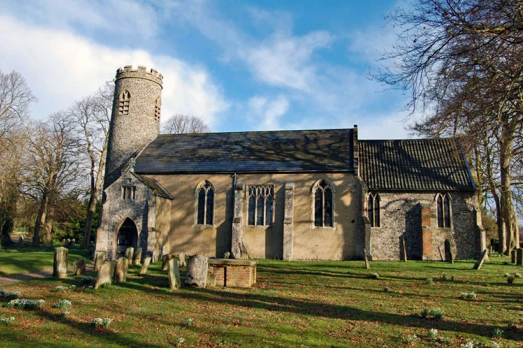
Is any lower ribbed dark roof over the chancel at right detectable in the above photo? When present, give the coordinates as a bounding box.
[359,139,476,191]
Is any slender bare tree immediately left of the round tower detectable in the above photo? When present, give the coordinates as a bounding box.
[68,84,114,247]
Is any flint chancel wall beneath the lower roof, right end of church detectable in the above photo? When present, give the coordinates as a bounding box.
[371,192,479,260]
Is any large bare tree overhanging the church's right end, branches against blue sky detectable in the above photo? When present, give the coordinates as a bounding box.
[374,0,523,252]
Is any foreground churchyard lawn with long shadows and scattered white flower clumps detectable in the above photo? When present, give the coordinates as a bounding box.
[0,257,523,347]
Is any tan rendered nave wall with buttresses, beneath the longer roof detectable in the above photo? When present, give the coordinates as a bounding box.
[147,173,363,260]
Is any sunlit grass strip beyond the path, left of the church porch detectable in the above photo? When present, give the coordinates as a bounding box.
[0,246,88,276]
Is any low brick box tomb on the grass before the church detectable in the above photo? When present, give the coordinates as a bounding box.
[208,258,257,288]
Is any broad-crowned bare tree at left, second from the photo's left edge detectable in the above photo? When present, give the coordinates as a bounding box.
[19,113,81,246]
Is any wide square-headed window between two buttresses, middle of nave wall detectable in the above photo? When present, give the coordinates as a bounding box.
[247,185,274,226]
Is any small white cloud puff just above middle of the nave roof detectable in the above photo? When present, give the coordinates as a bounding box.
[247,95,289,130]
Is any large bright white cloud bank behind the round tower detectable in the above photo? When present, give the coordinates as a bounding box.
[0,15,228,126]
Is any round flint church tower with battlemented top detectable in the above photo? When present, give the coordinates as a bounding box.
[104,66,163,188]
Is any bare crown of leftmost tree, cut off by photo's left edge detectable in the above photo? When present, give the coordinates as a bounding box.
[0,71,36,138]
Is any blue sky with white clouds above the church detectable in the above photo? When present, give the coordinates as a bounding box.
[0,0,418,139]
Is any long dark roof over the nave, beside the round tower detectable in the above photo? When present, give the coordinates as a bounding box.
[134,129,354,174]
